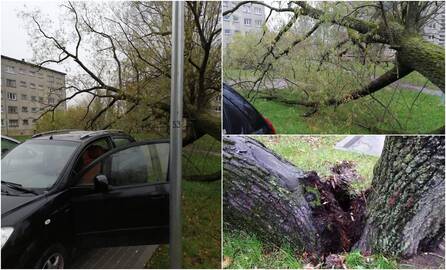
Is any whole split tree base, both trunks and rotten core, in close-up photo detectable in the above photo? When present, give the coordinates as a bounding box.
[223,136,444,256]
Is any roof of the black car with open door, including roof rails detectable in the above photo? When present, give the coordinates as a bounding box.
[32,130,130,142]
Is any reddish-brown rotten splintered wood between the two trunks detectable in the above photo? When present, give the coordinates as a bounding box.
[304,161,365,254]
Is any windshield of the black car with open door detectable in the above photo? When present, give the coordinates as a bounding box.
[2,140,79,188]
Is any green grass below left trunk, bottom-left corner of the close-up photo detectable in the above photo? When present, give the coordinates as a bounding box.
[223,231,302,269]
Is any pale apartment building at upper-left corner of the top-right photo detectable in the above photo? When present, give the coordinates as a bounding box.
[223,1,266,47]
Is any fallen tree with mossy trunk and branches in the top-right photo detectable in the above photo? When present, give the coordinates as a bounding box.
[223,1,445,134]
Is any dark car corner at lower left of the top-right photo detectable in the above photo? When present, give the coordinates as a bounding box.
[223,84,276,134]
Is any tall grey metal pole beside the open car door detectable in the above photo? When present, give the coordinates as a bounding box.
[169,1,184,269]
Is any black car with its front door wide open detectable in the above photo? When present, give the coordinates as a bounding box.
[1,130,169,268]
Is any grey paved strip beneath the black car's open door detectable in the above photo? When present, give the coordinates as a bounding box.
[69,245,157,269]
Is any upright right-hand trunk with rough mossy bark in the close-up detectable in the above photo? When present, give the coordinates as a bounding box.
[356,136,445,257]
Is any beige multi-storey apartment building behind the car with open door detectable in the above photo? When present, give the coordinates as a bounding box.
[0,55,66,135]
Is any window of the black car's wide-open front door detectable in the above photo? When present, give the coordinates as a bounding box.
[77,143,169,186]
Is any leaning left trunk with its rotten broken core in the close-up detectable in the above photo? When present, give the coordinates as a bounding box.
[223,136,364,255]
